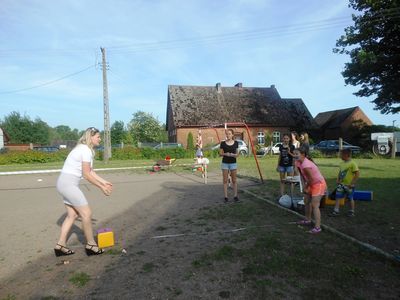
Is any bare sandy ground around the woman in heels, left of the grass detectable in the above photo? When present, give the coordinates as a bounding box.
[0,171,254,299]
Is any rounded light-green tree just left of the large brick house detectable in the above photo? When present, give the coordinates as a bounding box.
[128,111,165,144]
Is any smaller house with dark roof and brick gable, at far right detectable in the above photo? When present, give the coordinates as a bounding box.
[315,106,373,140]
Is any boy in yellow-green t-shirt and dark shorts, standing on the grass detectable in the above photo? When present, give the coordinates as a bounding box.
[329,149,360,217]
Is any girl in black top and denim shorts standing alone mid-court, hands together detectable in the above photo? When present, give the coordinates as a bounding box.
[219,129,239,203]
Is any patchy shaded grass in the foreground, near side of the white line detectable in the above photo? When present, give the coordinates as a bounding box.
[191,197,400,299]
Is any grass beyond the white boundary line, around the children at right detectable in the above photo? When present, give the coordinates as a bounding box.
[239,157,400,256]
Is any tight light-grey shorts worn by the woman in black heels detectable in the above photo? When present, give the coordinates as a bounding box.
[57,173,88,206]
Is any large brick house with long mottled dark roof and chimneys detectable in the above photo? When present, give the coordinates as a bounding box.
[166,83,317,146]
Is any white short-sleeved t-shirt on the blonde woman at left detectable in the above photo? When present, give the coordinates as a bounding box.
[61,144,93,177]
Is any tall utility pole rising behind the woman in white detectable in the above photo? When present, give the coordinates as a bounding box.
[100,48,111,163]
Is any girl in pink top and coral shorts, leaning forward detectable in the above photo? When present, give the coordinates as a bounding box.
[293,147,326,233]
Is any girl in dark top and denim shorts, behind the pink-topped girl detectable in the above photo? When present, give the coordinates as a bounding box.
[276,134,295,196]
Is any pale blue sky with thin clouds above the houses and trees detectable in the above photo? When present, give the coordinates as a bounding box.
[0,0,400,130]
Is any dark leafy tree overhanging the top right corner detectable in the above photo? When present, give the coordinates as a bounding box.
[333,0,400,114]
